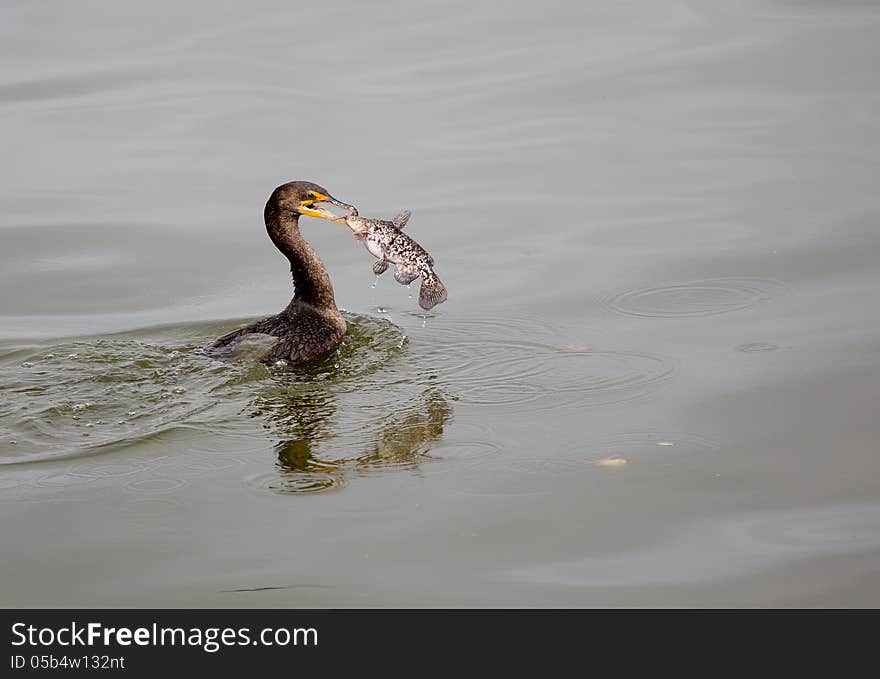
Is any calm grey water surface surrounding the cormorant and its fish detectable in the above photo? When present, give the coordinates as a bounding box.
[0,0,880,607]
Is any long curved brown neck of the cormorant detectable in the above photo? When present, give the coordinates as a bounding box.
[265,205,336,311]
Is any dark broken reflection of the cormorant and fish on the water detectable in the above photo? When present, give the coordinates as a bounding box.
[251,388,452,493]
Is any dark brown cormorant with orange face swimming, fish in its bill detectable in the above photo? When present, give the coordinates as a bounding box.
[208,181,356,365]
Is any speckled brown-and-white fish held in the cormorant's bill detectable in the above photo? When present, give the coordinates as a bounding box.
[338,211,447,310]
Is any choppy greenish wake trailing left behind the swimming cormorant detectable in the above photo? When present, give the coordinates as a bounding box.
[0,314,404,468]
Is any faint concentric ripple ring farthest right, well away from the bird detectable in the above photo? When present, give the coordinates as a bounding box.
[603,278,785,318]
